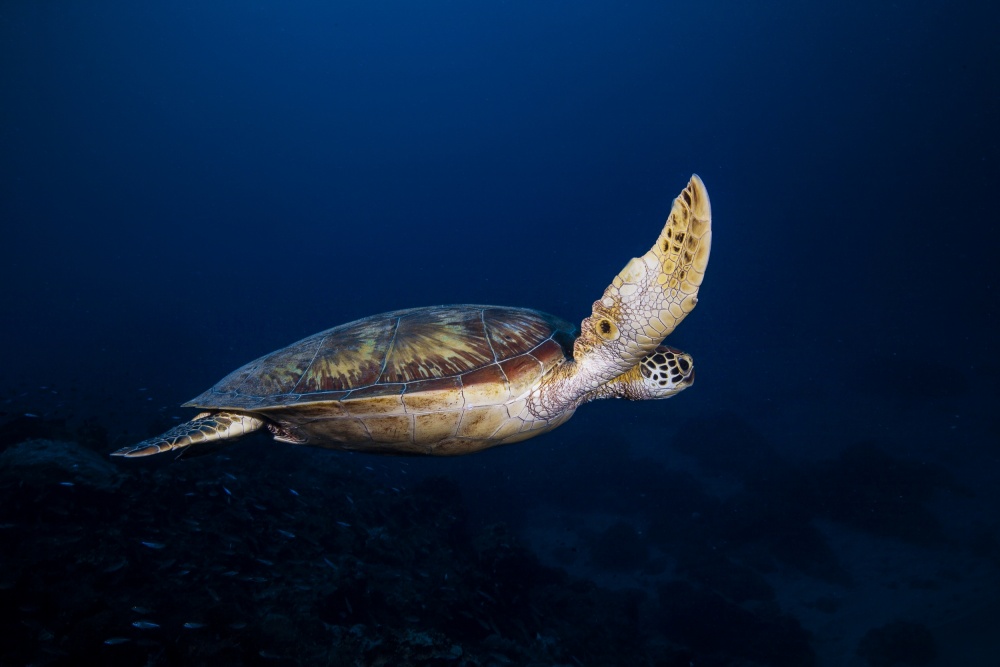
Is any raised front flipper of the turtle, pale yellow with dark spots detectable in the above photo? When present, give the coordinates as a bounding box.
[573,175,712,387]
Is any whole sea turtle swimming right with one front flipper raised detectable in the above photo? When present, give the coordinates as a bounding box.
[114,176,712,456]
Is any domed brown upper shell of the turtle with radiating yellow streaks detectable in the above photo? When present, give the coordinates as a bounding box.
[185,305,576,418]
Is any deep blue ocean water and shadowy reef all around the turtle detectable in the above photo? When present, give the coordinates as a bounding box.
[0,0,1000,667]
